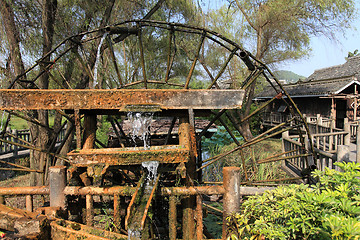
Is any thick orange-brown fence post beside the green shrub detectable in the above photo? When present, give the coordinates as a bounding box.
[222,167,241,239]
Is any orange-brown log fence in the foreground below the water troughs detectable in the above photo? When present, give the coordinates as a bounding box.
[0,166,274,240]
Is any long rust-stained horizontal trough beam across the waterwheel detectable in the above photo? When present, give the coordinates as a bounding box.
[0,89,244,111]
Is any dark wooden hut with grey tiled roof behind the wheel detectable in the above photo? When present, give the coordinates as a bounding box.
[254,56,360,128]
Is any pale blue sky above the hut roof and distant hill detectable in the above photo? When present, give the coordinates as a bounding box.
[204,0,360,77]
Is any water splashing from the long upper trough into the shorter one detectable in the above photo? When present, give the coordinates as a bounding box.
[127,112,153,150]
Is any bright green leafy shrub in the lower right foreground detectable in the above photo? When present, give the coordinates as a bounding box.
[228,163,360,239]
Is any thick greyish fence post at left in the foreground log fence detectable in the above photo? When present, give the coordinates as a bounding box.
[49,166,66,209]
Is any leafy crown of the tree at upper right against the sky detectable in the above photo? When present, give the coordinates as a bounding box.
[235,0,355,63]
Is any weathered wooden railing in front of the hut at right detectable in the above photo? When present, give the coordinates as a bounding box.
[270,113,360,180]
